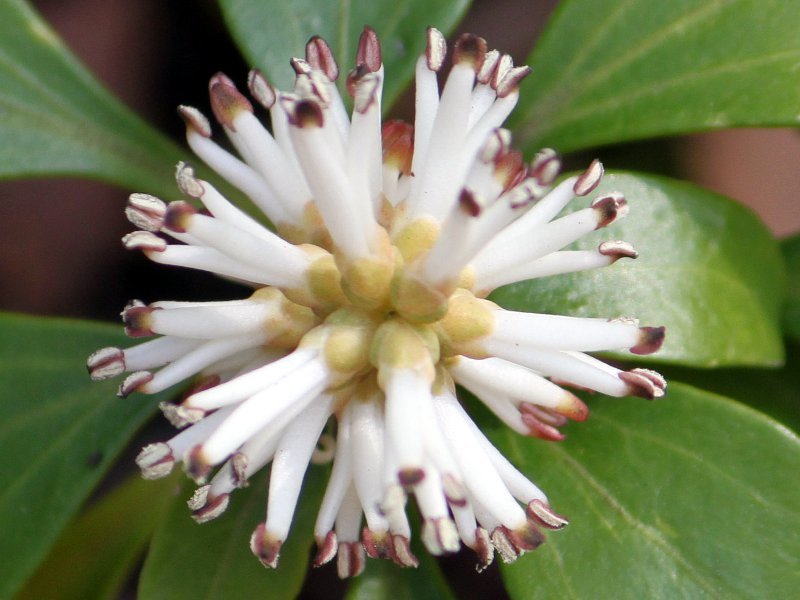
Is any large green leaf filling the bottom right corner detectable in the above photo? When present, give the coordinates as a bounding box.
[494,383,800,600]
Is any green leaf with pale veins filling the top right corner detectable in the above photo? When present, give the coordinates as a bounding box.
[513,0,800,152]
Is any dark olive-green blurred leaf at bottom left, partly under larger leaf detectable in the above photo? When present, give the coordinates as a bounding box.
[15,473,175,600]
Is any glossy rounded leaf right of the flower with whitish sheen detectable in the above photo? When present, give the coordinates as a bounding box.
[493,174,785,367]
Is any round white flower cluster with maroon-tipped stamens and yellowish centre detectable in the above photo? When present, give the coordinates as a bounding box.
[88,28,665,577]
